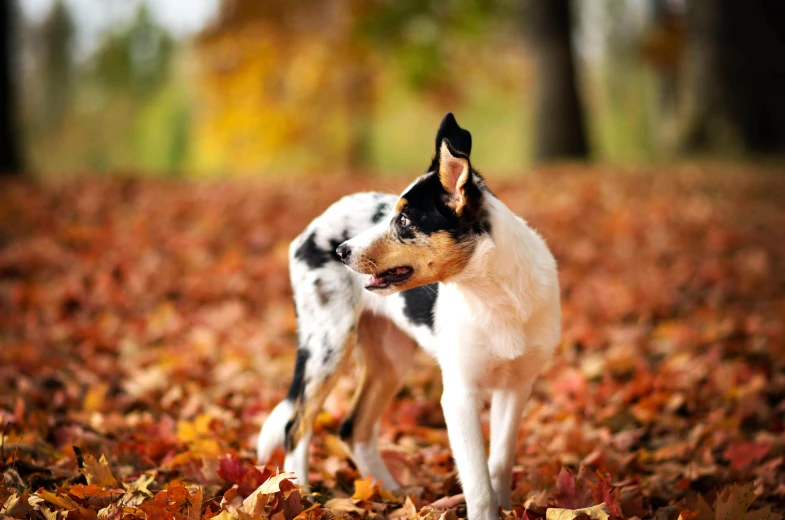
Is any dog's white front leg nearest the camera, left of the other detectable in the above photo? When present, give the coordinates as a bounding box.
[442,371,499,520]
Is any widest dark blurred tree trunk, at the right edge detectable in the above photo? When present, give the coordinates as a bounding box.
[682,0,785,153]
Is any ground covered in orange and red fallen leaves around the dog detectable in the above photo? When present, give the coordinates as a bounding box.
[0,166,785,520]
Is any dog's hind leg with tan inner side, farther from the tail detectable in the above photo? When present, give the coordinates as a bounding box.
[340,313,417,489]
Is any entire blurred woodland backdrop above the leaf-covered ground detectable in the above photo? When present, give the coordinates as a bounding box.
[6,0,785,175]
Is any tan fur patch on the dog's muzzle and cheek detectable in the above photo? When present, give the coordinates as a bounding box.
[353,231,475,290]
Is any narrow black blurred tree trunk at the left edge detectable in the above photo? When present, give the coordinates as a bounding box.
[0,0,22,176]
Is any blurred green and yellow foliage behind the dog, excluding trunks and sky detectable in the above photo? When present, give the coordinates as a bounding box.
[23,0,664,176]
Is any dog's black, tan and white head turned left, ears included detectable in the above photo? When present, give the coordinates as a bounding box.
[336,113,490,294]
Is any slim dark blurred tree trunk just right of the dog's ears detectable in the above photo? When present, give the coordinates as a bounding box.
[527,0,589,161]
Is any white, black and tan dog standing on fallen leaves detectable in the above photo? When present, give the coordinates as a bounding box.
[257,114,561,520]
